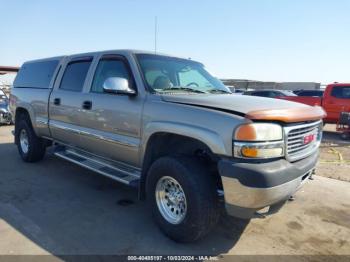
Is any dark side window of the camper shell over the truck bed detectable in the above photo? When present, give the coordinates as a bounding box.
[13,60,59,89]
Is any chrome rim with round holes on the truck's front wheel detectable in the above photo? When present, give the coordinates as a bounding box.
[155,176,187,224]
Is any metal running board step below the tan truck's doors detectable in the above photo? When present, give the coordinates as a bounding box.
[54,146,141,186]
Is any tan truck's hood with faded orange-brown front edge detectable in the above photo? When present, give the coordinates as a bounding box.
[161,94,325,122]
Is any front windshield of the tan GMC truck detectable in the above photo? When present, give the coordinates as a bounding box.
[136,54,231,94]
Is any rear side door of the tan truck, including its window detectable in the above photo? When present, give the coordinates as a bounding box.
[49,57,93,147]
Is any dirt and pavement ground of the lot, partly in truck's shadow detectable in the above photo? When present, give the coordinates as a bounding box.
[0,126,350,261]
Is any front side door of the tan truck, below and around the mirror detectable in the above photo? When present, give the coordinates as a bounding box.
[79,54,144,166]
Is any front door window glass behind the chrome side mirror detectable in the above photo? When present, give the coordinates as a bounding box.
[91,58,132,93]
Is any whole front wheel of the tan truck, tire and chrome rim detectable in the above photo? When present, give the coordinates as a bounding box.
[146,157,219,242]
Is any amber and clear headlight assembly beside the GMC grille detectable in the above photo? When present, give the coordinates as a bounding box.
[233,123,284,159]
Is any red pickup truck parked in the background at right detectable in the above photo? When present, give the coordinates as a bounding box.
[279,83,350,124]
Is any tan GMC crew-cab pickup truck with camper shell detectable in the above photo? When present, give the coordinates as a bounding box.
[10,50,324,242]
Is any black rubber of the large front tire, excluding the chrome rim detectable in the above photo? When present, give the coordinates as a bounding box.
[146,157,220,242]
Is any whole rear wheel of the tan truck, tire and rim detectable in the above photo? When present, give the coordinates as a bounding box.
[15,117,46,162]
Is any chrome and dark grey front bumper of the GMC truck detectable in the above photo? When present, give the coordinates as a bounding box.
[218,153,318,218]
